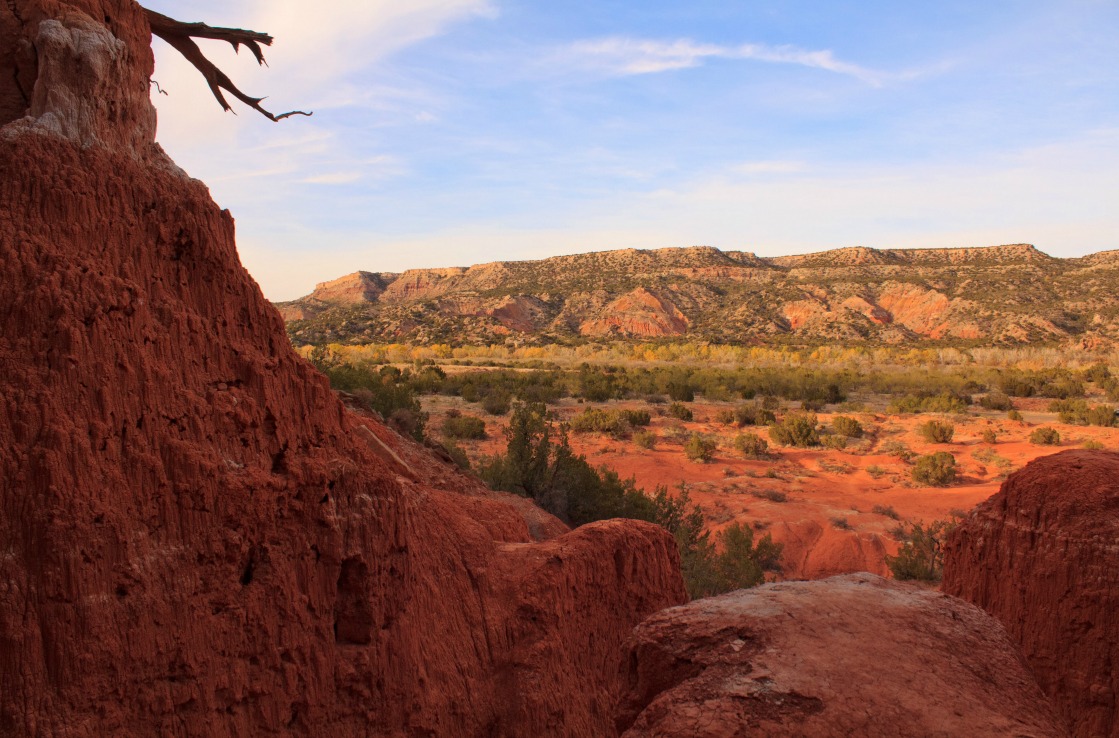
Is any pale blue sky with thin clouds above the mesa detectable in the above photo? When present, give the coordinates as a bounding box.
[147,0,1119,300]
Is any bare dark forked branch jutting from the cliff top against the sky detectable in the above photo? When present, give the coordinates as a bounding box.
[143,8,311,121]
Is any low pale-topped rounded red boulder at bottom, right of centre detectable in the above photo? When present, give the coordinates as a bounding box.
[618,574,1066,738]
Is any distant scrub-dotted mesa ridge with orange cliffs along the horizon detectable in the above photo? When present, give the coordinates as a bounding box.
[276,244,1119,347]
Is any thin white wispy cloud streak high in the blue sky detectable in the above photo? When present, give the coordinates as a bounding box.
[566,36,892,86]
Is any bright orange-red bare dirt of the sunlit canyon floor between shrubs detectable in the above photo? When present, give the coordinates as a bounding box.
[423,396,1119,579]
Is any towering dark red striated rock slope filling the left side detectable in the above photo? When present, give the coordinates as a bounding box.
[0,0,685,738]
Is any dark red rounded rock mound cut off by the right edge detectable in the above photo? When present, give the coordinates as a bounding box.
[943,451,1119,738]
